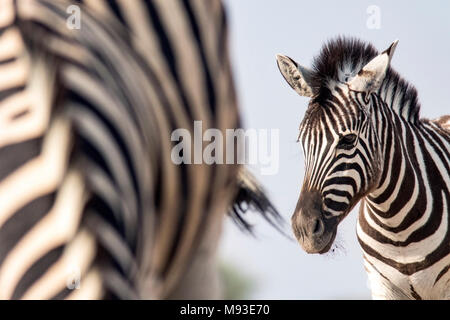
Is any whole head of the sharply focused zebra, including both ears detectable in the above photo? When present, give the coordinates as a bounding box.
[277,38,397,253]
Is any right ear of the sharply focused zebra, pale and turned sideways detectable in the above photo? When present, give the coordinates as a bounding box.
[348,40,398,92]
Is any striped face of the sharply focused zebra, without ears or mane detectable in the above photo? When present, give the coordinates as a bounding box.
[292,99,378,253]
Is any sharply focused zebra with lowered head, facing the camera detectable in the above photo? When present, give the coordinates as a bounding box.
[277,36,450,299]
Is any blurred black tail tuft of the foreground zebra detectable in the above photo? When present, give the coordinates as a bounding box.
[228,167,285,234]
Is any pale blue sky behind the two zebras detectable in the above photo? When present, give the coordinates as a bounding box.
[221,0,450,299]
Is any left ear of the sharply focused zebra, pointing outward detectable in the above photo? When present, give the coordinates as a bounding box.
[277,54,313,97]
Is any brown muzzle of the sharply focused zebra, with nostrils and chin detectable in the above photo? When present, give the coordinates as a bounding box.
[291,191,338,254]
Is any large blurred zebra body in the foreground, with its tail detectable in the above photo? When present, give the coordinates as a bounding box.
[0,0,279,299]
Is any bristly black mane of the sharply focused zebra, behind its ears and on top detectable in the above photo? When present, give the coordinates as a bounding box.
[310,37,420,121]
